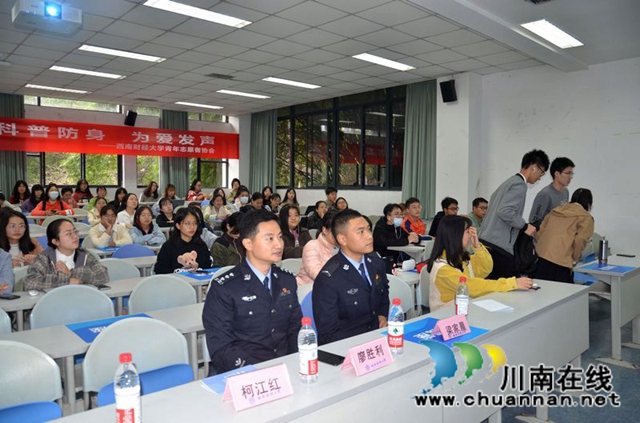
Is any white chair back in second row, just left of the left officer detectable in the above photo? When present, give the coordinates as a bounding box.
[129,275,196,314]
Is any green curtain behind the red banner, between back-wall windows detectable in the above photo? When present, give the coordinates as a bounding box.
[160,110,191,198]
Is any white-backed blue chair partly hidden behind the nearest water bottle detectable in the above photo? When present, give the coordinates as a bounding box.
[82,320,193,406]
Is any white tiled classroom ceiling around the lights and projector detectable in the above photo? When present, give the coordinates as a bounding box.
[0,0,640,115]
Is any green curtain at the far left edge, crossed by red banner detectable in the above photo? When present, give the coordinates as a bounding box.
[0,93,27,196]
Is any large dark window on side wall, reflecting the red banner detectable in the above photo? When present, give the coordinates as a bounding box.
[276,86,406,189]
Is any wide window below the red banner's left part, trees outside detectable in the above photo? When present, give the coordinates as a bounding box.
[27,153,122,187]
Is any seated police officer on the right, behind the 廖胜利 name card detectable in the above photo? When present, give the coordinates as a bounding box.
[312,209,389,345]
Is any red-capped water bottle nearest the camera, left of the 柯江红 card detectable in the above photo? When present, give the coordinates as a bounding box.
[113,353,140,423]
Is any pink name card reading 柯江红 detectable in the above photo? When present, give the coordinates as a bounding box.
[222,364,293,411]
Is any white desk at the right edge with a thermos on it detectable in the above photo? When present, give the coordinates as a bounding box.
[574,253,640,369]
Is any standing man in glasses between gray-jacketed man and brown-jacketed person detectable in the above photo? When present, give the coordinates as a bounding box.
[529,157,575,223]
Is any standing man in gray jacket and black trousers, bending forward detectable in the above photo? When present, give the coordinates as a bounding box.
[480,150,549,279]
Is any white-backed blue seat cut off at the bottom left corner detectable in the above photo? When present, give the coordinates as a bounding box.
[0,341,62,423]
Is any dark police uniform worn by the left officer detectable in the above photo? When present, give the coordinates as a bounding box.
[202,259,302,373]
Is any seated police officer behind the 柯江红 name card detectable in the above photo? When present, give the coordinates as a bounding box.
[202,210,302,373]
